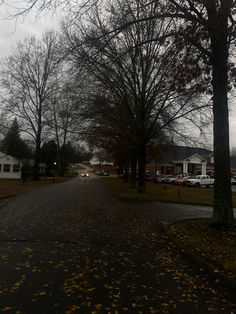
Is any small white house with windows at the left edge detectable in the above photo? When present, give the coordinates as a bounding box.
[0,152,21,179]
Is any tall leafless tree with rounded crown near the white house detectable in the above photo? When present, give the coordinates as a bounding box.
[1,32,58,180]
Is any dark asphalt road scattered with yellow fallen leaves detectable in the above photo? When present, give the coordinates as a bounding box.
[0,177,236,314]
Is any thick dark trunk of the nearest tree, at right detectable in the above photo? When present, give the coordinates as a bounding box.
[211,19,234,228]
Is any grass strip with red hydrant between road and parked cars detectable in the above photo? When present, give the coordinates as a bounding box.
[104,177,236,206]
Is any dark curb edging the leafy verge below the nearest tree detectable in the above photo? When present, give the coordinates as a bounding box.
[161,223,236,292]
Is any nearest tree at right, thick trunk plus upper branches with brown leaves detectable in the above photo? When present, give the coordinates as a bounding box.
[159,0,236,228]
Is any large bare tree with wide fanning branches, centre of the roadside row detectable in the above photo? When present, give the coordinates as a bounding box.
[65,1,212,192]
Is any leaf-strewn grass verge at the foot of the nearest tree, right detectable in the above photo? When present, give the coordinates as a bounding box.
[168,219,236,279]
